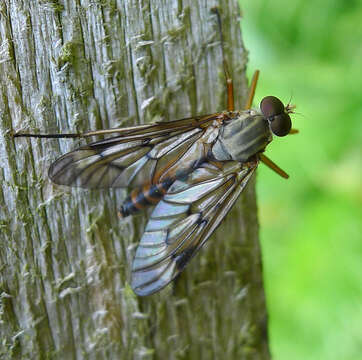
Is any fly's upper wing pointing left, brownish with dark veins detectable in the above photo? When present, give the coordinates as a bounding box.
[49,114,221,188]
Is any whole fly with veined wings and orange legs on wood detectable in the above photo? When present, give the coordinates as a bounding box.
[14,9,296,296]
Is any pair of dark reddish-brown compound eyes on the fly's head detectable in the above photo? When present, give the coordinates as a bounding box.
[260,96,292,136]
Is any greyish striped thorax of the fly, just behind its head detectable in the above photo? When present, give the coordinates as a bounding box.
[211,110,272,162]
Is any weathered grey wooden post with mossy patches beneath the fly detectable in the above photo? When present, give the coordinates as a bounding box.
[0,0,269,359]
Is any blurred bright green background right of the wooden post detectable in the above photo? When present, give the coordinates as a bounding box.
[240,0,362,360]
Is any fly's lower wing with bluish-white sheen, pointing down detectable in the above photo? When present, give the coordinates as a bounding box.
[131,160,258,296]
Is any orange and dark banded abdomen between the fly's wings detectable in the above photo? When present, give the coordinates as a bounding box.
[120,178,174,217]
